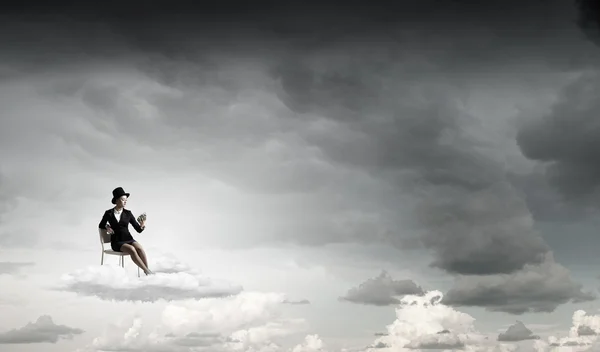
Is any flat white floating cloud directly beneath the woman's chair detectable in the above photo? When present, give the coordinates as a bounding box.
[56,257,243,302]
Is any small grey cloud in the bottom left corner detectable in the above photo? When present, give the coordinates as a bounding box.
[0,315,84,344]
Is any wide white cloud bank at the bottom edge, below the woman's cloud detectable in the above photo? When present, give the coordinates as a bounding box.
[78,292,314,352]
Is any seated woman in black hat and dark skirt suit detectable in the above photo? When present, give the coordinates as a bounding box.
[98,187,153,275]
